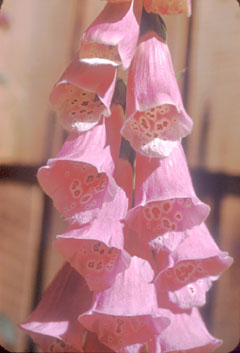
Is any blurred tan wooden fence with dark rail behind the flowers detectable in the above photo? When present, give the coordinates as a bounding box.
[0,0,240,353]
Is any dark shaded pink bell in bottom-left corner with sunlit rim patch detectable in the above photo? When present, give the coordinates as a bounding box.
[20,263,92,352]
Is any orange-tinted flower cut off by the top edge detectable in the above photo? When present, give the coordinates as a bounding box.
[144,0,192,16]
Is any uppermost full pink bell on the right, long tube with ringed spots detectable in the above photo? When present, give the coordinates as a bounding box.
[121,31,192,158]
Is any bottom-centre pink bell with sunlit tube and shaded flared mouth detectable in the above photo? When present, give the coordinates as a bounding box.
[79,257,169,351]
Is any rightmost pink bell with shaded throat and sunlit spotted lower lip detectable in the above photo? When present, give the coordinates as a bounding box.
[154,223,233,309]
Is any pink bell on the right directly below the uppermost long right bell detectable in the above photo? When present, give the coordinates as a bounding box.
[126,146,210,242]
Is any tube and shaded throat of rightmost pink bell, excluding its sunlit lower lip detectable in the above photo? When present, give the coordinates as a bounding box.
[155,223,233,295]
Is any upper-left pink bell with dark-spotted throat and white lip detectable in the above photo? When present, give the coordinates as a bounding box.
[50,56,117,131]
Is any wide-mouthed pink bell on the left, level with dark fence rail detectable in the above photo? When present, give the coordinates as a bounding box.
[38,105,123,224]
